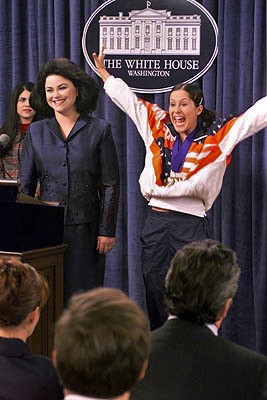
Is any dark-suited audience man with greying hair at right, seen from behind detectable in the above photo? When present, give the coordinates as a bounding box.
[131,239,267,400]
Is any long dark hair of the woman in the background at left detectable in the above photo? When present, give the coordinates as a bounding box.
[0,81,38,153]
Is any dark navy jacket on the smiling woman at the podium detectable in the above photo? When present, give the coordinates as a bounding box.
[19,115,119,236]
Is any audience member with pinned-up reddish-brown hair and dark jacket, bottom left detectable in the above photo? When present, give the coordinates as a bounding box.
[0,258,63,400]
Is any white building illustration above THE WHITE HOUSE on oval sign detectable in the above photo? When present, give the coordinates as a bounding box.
[99,1,201,55]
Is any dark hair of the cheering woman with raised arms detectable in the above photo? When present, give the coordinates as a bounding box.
[171,83,216,131]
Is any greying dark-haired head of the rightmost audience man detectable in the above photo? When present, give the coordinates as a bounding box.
[165,239,240,324]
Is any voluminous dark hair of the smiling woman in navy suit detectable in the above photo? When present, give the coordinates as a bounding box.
[30,58,99,118]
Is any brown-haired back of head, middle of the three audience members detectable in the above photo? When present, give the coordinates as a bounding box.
[55,288,149,398]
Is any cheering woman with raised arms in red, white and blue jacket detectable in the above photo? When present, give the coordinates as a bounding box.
[93,49,267,329]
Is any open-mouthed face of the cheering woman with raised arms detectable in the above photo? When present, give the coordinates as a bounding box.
[169,89,203,140]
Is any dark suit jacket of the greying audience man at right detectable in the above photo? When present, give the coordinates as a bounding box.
[131,319,267,400]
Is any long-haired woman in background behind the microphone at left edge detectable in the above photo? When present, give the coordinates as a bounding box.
[0,81,37,179]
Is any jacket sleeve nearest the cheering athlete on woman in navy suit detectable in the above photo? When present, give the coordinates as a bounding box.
[98,124,119,237]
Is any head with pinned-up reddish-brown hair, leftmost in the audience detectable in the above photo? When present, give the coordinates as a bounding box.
[0,258,48,341]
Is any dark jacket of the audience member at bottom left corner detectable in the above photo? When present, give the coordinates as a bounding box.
[0,337,63,400]
